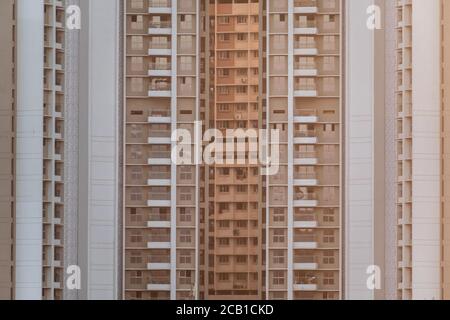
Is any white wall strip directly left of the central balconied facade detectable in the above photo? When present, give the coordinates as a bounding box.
[79,0,121,300]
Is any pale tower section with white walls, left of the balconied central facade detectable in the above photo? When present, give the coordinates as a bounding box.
[0,0,121,300]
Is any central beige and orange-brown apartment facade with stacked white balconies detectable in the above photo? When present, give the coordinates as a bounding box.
[123,1,343,299]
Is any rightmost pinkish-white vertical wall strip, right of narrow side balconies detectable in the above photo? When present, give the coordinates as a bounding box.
[412,0,441,299]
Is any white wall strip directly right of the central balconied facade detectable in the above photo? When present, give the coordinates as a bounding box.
[343,0,375,300]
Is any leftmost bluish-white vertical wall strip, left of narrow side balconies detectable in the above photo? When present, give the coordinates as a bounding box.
[15,0,44,300]
